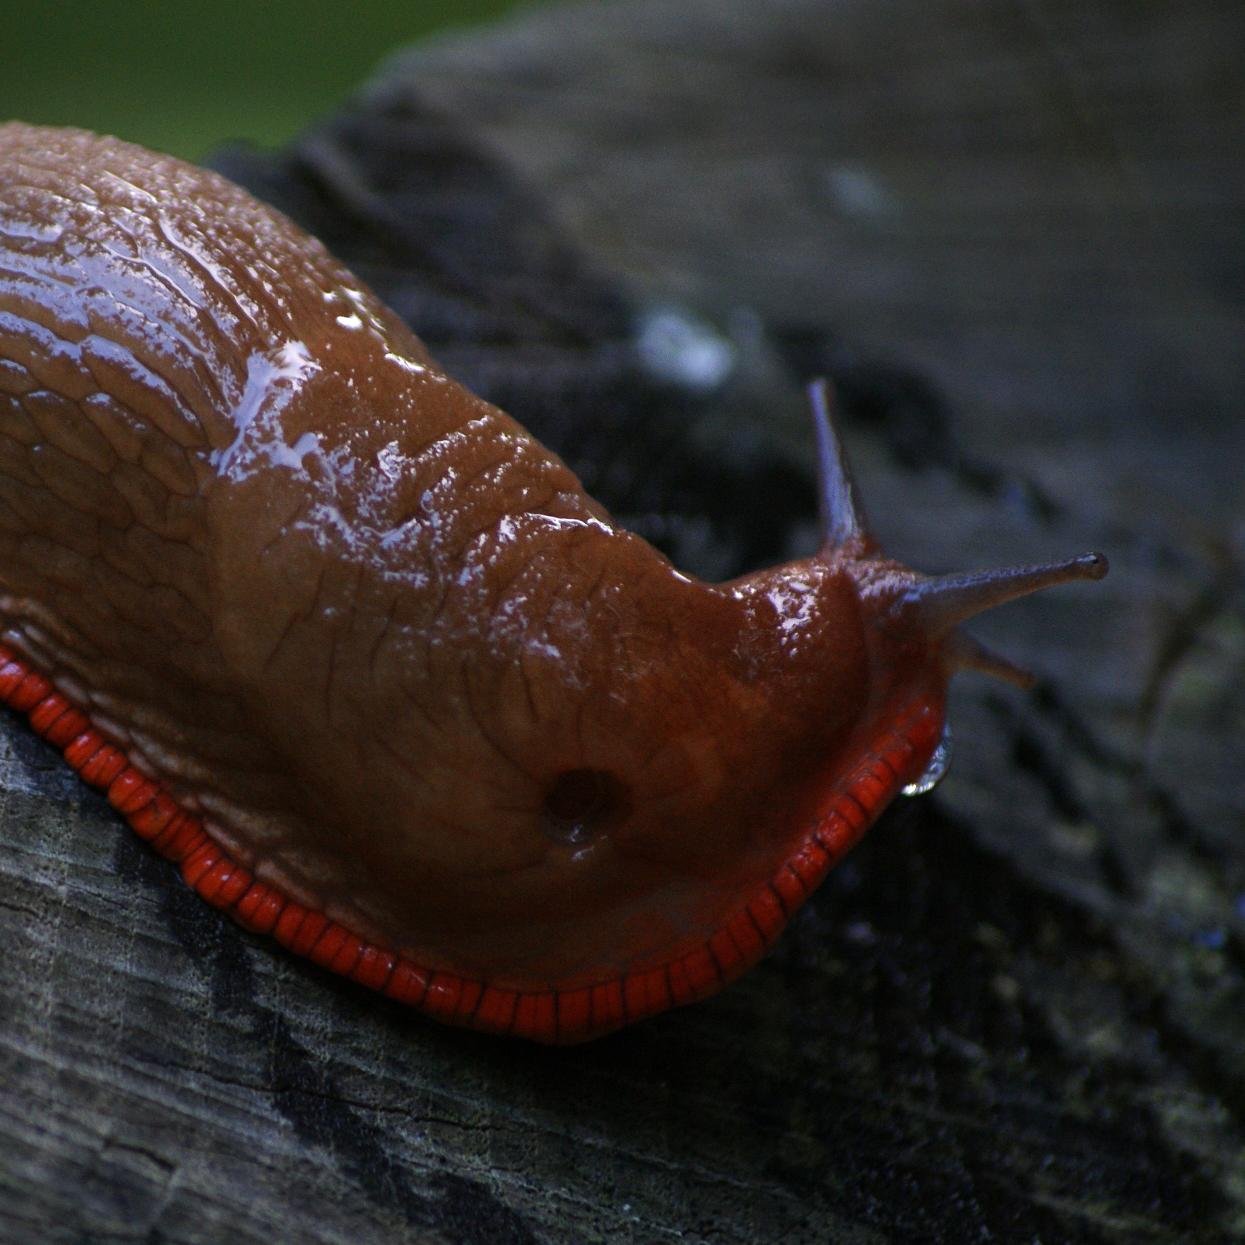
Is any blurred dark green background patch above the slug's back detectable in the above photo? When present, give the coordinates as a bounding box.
[0,0,533,159]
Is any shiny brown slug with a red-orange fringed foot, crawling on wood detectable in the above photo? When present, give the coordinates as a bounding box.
[0,125,1107,1042]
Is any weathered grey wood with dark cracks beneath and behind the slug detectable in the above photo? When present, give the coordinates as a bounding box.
[0,0,1245,1243]
